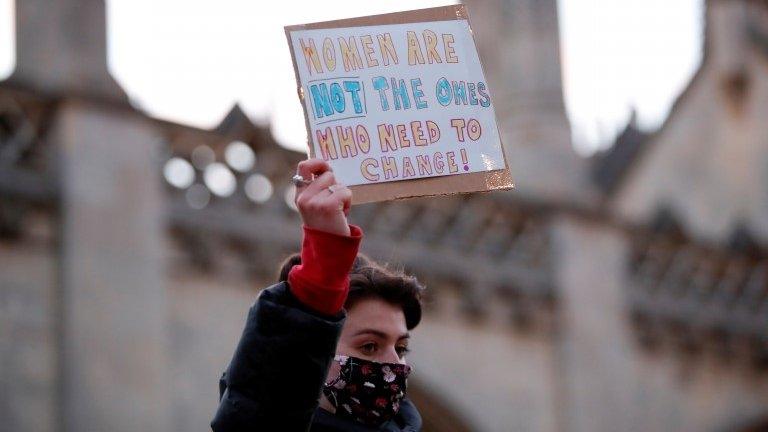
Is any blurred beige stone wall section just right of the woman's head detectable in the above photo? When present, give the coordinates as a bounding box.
[409,287,558,432]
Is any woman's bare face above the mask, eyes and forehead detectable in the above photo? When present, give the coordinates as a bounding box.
[336,298,410,363]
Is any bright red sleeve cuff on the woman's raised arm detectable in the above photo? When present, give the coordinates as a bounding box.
[288,225,363,315]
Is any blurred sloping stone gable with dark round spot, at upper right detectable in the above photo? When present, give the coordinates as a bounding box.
[613,1,768,242]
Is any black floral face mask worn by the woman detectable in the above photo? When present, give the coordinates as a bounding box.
[323,355,412,426]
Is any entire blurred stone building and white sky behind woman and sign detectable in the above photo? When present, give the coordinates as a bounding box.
[0,0,768,432]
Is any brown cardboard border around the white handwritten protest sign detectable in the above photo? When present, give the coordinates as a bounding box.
[284,4,514,204]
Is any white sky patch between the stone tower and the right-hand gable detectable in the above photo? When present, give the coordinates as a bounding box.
[558,0,704,154]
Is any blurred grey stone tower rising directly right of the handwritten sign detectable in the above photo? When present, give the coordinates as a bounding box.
[465,0,594,202]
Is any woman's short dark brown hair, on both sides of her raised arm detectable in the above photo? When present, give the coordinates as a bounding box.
[278,254,424,330]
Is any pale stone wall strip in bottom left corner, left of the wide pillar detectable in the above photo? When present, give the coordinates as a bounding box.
[0,217,59,432]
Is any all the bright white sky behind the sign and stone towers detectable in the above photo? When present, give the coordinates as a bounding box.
[0,0,703,155]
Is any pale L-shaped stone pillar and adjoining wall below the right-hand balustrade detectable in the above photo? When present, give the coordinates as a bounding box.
[556,218,768,432]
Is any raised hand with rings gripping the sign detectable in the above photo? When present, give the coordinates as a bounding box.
[295,159,352,236]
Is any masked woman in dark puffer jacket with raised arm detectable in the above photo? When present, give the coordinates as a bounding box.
[211,159,422,432]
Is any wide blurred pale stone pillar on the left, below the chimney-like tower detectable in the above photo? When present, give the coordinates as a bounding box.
[52,101,170,432]
